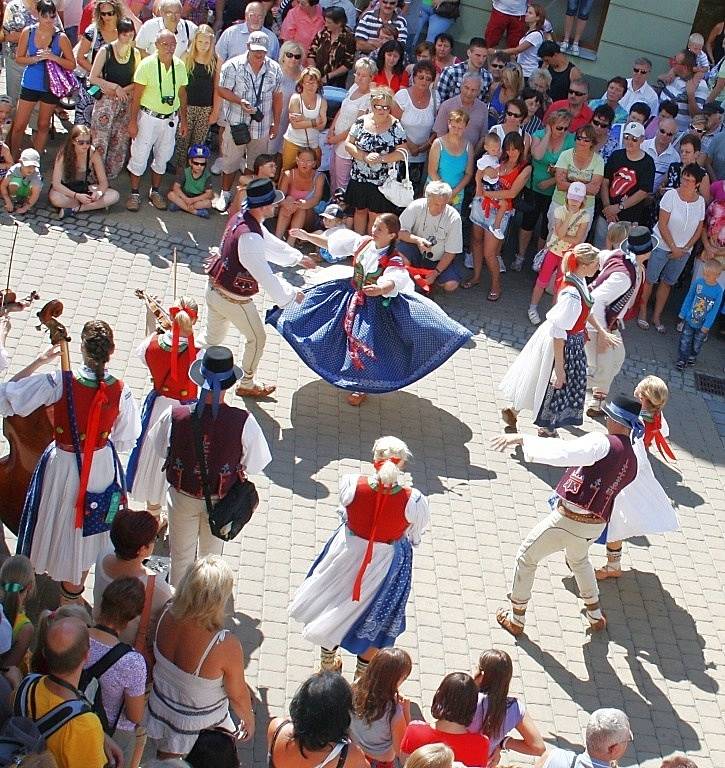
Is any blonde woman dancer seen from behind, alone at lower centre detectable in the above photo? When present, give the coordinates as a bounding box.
[289,436,430,676]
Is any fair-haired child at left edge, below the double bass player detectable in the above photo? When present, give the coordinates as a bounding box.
[0,555,35,674]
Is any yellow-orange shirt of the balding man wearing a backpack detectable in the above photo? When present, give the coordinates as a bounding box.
[23,678,106,768]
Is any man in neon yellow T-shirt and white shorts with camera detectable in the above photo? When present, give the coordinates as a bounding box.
[126,29,188,211]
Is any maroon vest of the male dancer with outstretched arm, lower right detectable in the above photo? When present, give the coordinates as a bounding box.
[556,435,637,522]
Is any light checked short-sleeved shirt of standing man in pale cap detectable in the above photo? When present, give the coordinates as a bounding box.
[219,53,282,139]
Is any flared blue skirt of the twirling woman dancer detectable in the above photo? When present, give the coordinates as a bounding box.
[267,279,472,393]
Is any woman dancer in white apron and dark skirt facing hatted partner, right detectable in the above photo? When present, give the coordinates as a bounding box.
[499,243,618,437]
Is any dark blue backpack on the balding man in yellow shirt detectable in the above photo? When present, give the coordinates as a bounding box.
[0,674,91,765]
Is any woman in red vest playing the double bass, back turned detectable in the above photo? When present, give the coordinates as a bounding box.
[0,316,141,602]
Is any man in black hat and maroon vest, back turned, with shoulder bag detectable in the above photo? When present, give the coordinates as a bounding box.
[149,346,272,587]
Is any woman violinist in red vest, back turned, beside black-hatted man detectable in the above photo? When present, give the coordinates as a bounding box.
[126,296,199,521]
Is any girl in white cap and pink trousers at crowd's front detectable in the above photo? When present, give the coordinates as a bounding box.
[528,181,591,325]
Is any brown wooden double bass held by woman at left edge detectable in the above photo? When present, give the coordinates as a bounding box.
[0,300,70,534]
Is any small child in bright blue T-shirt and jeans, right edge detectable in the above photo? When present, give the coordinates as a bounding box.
[676,259,723,371]
